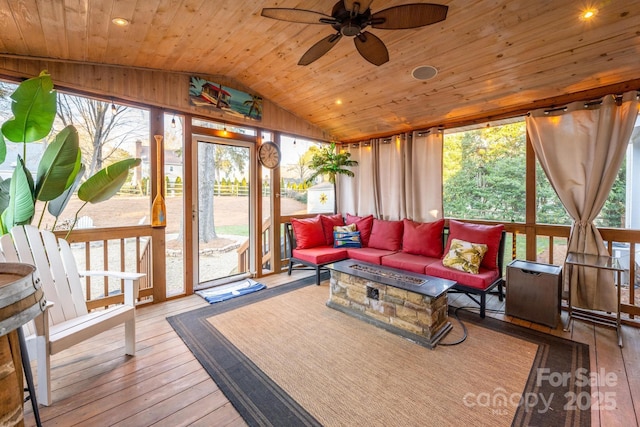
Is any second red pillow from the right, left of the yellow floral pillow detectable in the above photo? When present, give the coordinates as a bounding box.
[402,218,444,258]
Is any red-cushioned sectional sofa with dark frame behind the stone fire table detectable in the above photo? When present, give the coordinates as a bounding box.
[285,214,505,317]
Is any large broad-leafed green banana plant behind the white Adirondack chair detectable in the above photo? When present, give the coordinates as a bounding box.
[0,71,141,234]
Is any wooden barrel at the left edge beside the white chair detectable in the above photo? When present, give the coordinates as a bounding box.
[0,262,46,426]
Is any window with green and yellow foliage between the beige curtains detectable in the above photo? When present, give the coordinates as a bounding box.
[443,118,526,222]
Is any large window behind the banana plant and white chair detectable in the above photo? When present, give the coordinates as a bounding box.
[0,82,150,229]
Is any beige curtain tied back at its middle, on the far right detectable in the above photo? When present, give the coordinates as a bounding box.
[526,92,638,312]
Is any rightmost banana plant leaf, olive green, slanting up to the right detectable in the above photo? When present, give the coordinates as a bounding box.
[78,159,141,203]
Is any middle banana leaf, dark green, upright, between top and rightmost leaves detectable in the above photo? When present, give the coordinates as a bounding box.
[36,125,82,202]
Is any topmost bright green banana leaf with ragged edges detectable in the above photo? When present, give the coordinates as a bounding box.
[2,71,57,142]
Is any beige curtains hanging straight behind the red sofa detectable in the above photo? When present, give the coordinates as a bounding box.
[338,129,443,222]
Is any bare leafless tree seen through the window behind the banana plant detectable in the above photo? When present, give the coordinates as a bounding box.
[57,94,147,175]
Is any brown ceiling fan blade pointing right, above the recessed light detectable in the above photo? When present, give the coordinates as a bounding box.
[371,3,449,30]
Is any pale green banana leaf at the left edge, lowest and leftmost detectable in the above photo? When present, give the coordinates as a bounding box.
[2,156,35,230]
